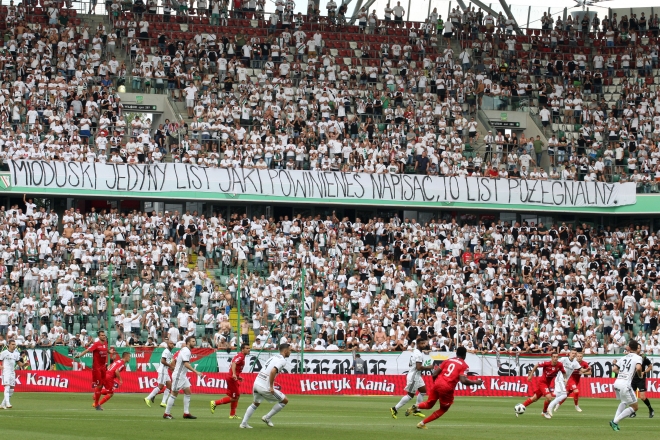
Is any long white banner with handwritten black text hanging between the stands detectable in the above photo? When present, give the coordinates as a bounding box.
[9,160,636,207]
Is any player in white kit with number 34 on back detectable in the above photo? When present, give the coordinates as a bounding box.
[610,339,644,431]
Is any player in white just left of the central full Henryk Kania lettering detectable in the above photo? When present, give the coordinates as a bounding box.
[240,344,291,429]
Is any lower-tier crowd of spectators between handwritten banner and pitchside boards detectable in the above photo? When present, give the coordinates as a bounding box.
[0,199,660,354]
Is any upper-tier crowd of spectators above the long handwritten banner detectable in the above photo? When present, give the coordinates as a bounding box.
[0,2,660,192]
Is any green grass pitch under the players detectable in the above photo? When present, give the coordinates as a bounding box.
[0,393,660,440]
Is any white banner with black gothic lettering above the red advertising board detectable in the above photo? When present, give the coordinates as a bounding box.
[216,350,660,378]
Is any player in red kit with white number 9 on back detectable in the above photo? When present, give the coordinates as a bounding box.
[406,346,483,429]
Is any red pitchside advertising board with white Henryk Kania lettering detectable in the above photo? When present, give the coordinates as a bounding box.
[0,370,660,399]
